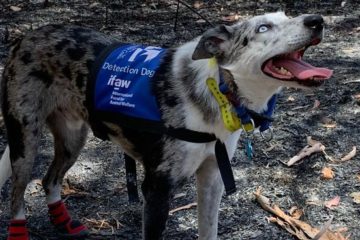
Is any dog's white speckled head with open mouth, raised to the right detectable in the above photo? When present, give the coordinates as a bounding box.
[192,12,332,93]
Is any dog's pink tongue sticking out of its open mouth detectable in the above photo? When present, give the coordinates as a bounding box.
[273,58,332,80]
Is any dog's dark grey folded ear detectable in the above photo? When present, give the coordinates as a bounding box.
[192,25,233,60]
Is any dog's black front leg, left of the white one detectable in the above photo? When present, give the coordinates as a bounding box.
[141,171,172,240]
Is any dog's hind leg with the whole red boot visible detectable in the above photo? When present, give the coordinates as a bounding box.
[43,109,89,238]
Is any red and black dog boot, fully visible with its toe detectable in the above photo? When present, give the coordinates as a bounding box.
[48,200,89,238]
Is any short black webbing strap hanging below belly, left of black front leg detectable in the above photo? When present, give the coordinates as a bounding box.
[124,154,140,203]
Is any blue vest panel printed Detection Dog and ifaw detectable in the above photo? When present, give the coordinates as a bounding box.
[94,44,166,121]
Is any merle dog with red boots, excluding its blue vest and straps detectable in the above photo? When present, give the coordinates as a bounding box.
[0,12,331,240]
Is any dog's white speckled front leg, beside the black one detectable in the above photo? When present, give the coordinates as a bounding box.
[196,157,224,240]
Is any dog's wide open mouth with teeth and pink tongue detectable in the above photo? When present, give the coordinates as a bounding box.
[261,39,333,87]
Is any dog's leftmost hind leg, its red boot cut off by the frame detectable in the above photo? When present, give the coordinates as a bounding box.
[3,102,41,240]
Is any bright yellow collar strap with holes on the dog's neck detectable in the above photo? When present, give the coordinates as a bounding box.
[206,78,243,132]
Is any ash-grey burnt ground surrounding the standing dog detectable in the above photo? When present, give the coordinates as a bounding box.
[0,0,360,240]
